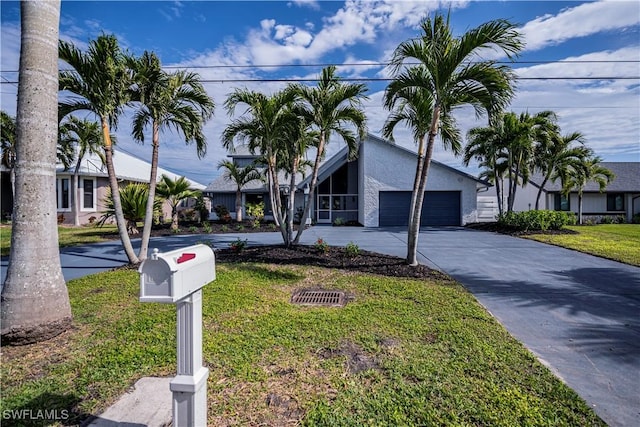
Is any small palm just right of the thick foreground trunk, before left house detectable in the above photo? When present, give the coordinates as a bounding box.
[59,116,104,226]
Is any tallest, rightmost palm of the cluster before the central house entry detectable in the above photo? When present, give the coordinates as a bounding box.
[292,65,368,244]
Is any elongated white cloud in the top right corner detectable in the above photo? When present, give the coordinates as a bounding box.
[522,1,640,50]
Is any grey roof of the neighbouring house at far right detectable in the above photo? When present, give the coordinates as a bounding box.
[530,162,640,193]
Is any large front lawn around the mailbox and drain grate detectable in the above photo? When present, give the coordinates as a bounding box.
[0,264,604,426]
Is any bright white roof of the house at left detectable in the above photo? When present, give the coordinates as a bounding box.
[56,151,205,190]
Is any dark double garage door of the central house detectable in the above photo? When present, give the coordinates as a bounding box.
[379,191,461,227]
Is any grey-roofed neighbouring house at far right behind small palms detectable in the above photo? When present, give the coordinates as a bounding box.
[478,162,640,222]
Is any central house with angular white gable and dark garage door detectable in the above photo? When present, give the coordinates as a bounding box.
[205,135,490,227]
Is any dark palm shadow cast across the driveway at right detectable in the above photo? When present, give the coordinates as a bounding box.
[454,268,640,366]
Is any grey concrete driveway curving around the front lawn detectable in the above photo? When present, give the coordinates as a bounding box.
[2,226,640,426]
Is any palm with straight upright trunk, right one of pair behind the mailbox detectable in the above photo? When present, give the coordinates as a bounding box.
[129,52,215,260]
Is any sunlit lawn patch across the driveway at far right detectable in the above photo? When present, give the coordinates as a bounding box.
[523,224,640,266]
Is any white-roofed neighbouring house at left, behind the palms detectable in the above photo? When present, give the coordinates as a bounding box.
[56,151,205,224]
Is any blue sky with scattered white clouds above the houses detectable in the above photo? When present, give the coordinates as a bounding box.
[0,0,640,185]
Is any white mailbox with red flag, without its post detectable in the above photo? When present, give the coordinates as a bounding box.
[138,245,216,303]
